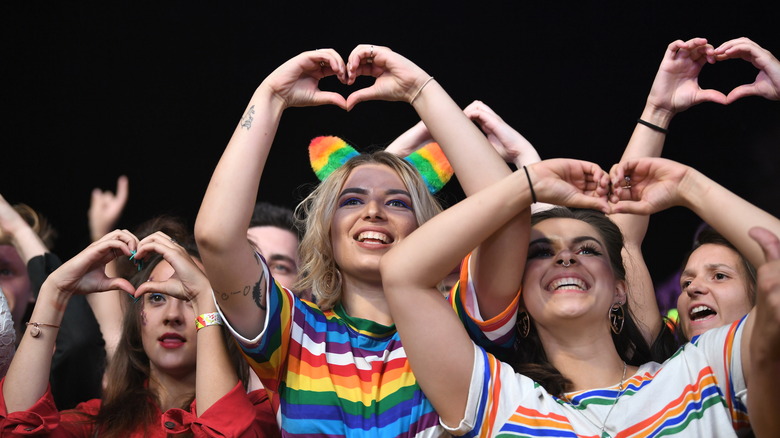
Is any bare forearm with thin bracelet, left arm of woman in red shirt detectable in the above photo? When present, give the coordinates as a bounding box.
[3,283,68,413]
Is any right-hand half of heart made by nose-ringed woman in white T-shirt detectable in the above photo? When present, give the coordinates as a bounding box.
[610,158,691,215]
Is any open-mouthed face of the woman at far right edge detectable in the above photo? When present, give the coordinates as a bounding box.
[677,244,753,339]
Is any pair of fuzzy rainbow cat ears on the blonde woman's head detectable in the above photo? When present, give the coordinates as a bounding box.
[309,136,453,193]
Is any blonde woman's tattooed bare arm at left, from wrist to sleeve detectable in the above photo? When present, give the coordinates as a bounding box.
[195,85,284,337]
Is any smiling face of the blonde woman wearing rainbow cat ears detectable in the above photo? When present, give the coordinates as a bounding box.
[330,164,424,282]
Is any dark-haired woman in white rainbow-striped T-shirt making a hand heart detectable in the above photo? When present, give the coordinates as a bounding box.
[381,158,780,437]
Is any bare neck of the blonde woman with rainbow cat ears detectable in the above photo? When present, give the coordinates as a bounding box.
[341,275,393,325]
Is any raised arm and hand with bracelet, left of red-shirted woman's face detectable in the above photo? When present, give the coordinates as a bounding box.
[3,231,138,413]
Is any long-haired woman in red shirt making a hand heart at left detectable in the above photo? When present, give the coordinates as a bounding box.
[0,222,276,437]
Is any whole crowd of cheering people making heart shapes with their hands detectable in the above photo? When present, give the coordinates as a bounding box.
[0,38,780,437]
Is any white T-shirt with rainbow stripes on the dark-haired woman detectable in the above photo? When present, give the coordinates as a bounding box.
[460,319,750,437]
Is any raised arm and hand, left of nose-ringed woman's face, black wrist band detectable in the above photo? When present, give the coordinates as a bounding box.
[381,160,607,425]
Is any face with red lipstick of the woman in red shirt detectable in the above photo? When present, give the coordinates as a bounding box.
[141,260,197,378]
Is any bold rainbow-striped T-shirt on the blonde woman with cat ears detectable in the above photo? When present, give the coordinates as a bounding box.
[227,268,444,438]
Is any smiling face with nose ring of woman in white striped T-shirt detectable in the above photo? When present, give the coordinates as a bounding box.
[522,218,626,332]
